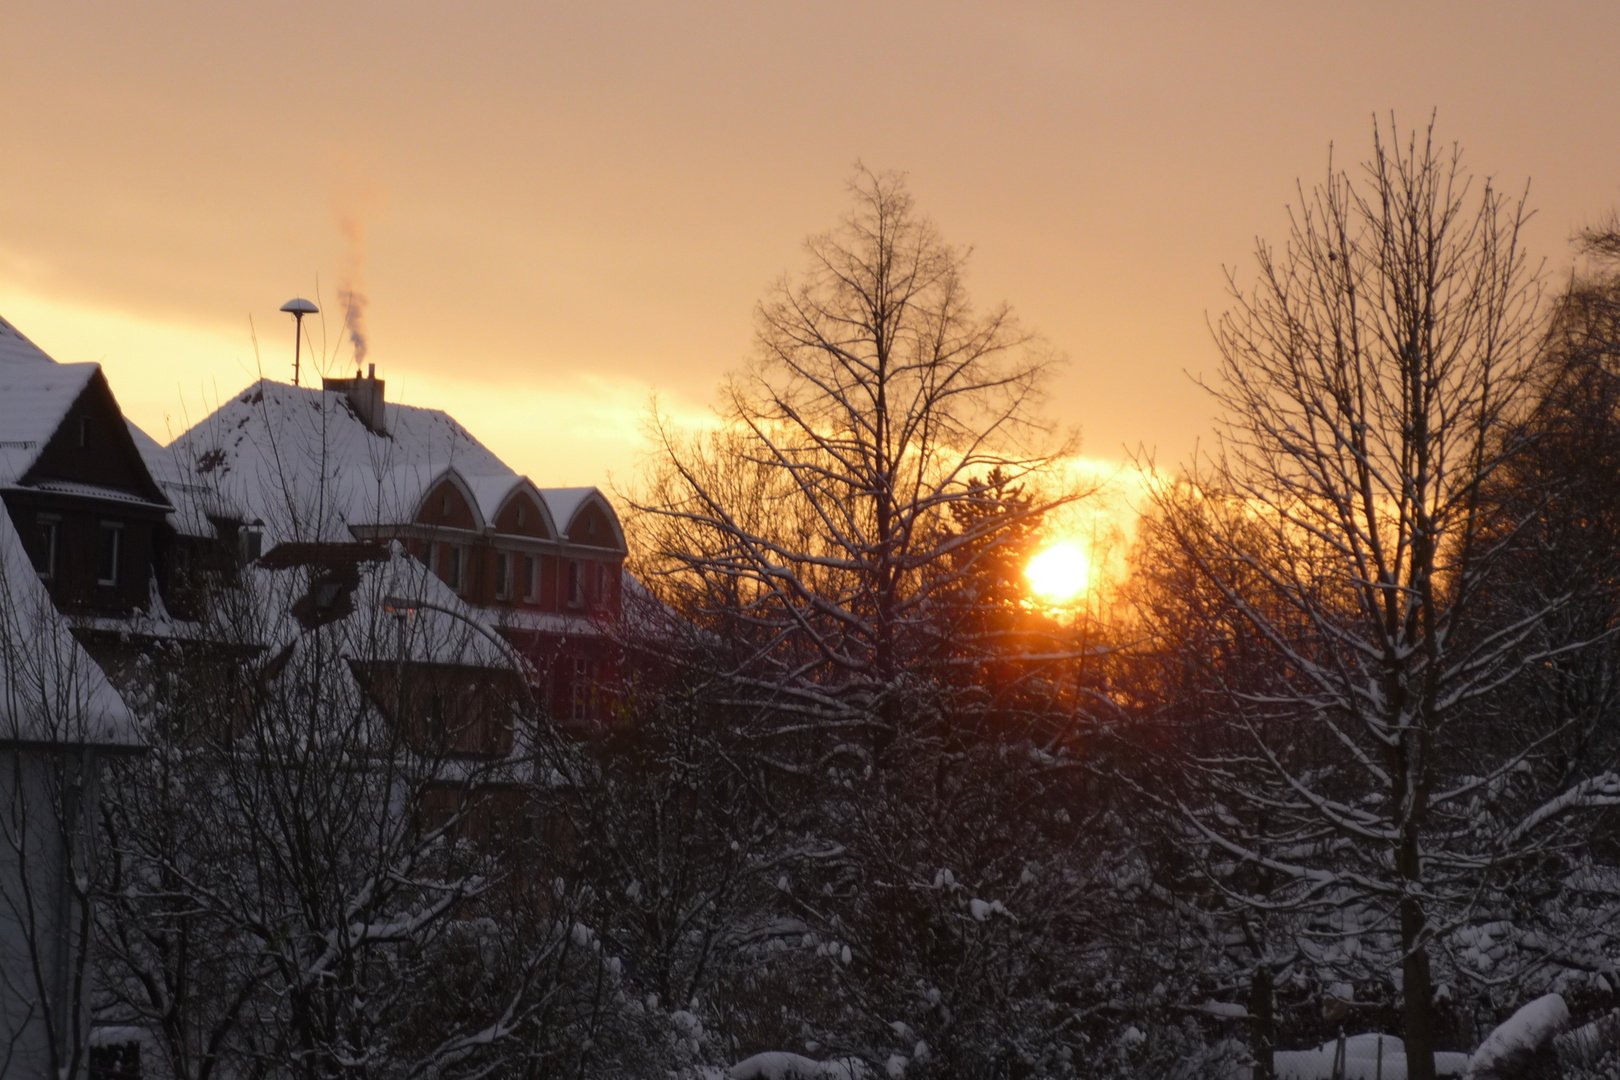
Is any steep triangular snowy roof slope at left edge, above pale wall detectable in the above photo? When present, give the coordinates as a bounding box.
[0,512,141,746]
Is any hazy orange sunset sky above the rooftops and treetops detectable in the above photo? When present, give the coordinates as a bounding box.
[0,0,1620,498]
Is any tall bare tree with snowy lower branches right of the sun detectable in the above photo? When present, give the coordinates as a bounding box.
[1157,126,1620,1080]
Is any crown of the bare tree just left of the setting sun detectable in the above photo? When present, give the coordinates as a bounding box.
[637,168,1072,743]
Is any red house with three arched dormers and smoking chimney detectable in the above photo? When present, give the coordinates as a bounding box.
[168,366,625,727]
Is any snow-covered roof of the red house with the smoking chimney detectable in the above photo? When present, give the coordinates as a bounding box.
[168,379,612,546]
